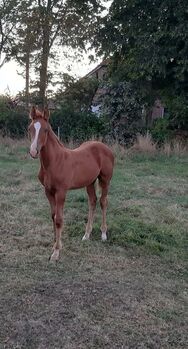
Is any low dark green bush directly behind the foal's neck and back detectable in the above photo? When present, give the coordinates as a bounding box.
[50,105,104,142]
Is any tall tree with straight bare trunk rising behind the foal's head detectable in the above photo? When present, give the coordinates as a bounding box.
[18,0,106,105]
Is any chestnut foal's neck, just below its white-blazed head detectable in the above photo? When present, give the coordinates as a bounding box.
[40,129,65,170]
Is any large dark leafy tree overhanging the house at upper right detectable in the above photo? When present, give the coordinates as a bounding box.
[94,0,188,127]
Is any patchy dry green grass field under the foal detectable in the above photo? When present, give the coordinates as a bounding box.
[0,142,188,349]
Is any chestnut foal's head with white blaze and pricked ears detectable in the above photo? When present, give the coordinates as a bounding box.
[28,107,50,158]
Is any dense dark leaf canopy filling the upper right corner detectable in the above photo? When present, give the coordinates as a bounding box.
[97,0,188,83]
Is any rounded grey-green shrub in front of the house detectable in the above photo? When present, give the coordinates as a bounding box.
[102,82,143,144]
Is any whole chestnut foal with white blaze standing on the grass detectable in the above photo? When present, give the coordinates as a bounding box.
[28,107,114,260]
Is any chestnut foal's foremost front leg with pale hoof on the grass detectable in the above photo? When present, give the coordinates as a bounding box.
[50,191,66,261]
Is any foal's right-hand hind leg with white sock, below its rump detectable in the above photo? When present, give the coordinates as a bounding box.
[99,179,109,241]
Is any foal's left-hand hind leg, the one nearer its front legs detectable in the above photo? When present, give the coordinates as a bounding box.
[82,183,97,240]
